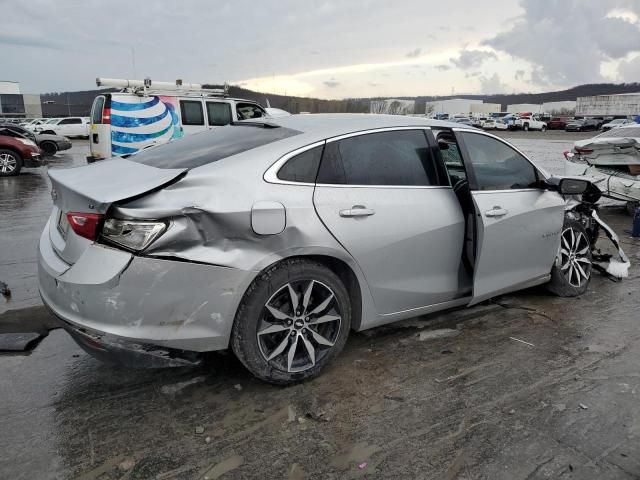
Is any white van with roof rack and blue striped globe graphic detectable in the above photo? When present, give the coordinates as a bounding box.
[87,78,267,163]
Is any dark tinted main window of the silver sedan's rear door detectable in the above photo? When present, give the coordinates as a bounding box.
[318,130,438,186]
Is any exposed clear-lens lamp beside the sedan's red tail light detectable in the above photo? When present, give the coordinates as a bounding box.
[101,218,167,252]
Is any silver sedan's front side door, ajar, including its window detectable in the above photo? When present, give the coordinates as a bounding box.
[456,131,565,305]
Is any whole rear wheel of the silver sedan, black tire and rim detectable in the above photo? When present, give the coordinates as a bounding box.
[231,259,351,385]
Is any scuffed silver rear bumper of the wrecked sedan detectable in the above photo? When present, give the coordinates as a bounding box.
[38,224,254,356]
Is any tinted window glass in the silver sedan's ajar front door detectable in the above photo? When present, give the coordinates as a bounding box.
[461,132,538,190]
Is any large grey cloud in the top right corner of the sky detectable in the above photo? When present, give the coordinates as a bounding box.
[483,0,640,86]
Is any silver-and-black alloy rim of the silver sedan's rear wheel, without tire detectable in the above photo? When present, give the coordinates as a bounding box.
[257,280,342,373]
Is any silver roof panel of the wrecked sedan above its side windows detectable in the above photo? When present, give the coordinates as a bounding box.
[254,113,460,140]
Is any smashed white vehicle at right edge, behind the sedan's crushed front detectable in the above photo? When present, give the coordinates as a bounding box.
[565,123,640,215]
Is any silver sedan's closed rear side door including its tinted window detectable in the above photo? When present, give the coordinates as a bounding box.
[313,128,464,314]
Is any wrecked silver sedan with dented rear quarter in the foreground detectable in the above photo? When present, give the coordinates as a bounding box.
[39,115,593,384]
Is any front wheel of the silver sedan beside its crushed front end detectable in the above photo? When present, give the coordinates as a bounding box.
[547,217,593,297]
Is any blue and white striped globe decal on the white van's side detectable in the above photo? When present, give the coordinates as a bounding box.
[111,95,182,155]
